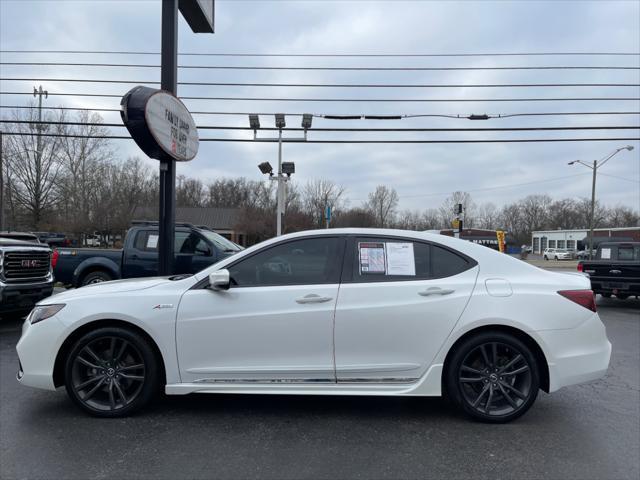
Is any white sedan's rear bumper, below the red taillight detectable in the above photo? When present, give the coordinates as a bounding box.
[537,314,611,392]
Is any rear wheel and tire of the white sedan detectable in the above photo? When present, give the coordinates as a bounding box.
[445,332,540,423]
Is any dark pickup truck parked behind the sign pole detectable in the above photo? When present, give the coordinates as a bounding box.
[51,222,242,287]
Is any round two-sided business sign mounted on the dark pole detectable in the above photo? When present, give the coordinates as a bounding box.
[120,86,199,162]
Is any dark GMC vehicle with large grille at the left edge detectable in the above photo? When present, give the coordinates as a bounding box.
[0,234,53,315]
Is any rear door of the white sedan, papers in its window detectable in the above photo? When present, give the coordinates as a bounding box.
[335,237,478,383]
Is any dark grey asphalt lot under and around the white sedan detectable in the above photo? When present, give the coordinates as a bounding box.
[0,298,640,480]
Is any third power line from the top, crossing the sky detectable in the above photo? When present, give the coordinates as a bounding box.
[5,77,640,88]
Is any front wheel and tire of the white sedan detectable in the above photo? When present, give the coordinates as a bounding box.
[64,327,161,418]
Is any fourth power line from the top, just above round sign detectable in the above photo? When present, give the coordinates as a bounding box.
[0,92,640,103]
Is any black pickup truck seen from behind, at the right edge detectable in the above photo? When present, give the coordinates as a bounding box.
[578,242,640,300]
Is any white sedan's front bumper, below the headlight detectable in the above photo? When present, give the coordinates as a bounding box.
[16,315,64,390]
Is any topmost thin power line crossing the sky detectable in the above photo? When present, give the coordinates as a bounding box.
[0,50,640,58]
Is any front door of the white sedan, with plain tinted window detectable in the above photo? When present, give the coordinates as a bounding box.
[176,236,345,383]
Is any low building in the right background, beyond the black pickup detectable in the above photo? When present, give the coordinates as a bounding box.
[531,227,640,254]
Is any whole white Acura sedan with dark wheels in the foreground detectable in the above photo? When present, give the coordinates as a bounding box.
[17,229,611,422]
